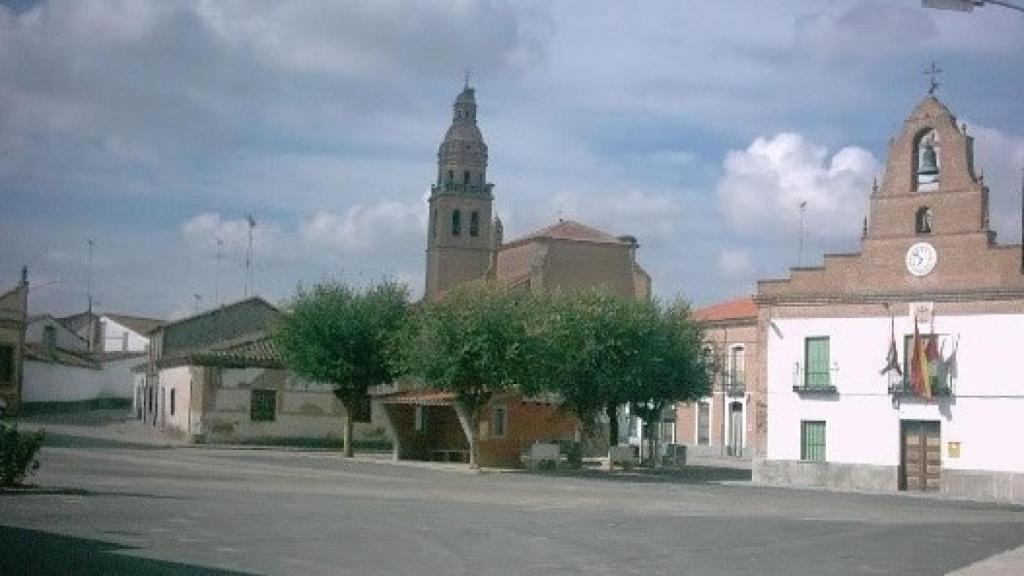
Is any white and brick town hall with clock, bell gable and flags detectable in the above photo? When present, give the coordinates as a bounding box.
[754,94,1024,501]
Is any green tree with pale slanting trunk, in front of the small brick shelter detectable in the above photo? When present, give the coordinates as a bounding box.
[392,286,538,467]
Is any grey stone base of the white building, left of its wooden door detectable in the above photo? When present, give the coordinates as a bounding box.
[753,458,898,492]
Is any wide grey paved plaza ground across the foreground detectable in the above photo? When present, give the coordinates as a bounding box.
[0,409,1024,576]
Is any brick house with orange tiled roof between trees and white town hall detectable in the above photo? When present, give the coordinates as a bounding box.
[676,296,767,458]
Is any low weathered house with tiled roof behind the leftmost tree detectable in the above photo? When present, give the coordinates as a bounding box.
[146,297,383,443]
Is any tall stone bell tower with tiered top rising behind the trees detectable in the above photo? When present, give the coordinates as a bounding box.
[424,83,494,298]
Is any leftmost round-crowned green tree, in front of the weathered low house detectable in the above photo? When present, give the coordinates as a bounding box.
[274,281,409,457]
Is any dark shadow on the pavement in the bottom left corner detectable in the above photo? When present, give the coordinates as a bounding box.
[0,526,258,576]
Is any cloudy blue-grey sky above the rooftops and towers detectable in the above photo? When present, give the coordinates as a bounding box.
[0,0,1024,318]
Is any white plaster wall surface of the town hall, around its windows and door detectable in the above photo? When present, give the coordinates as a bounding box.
[766,315,1024,472]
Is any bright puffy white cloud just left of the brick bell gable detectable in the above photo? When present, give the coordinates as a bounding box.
[717,132,879,238]
